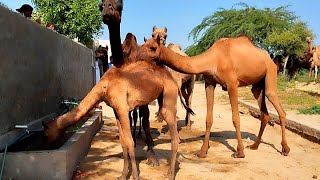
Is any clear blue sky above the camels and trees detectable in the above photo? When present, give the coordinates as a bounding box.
[0,0,320,49]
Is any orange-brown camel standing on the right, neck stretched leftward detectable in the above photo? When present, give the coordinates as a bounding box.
[139,36,290,158]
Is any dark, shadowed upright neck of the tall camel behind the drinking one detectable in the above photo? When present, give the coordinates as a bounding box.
[108,24,124,67]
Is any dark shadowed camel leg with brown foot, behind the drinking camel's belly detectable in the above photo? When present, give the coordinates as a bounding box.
[140,105,159,167]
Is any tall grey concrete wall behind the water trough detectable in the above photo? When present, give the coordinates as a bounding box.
[0,6,95,134]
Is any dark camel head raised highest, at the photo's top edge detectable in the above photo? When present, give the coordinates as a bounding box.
[99,0,123,25]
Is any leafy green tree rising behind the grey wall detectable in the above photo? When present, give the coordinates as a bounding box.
[32,0,102,44]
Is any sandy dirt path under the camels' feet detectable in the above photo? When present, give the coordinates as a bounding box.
[79,84,320,180]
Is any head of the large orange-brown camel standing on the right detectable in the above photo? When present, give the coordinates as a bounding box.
[138,36,162,60]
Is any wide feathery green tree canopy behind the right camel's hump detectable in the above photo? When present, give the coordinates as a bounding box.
[186,3,312,56]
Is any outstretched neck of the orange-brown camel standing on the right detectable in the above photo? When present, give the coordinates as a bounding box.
[159,45,208,74]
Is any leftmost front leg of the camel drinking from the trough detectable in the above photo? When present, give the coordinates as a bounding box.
[117,119,129,180]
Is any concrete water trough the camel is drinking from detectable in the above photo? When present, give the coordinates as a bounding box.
[0,111,103,180]
